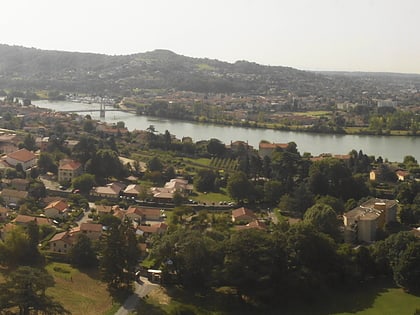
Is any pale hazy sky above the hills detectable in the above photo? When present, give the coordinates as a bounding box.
[0,0,420,73]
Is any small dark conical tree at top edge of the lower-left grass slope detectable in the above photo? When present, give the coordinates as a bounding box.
[70,233,98,268]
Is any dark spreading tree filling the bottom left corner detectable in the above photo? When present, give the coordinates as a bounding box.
[0,267,70,315]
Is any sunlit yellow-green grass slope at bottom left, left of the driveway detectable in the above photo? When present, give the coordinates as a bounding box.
[46,263,120,315]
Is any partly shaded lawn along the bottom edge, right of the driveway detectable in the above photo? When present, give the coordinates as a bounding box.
[138,281,420,315]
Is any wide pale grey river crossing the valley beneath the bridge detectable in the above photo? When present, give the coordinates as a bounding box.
[32,101,420,162]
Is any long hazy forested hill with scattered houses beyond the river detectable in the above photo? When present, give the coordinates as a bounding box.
[0,45,420,96]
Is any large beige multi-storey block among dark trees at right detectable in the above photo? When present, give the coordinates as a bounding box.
[343,198,398,243]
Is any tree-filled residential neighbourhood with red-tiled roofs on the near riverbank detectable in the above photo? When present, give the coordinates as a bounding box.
[0,70,420,310]
